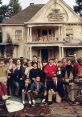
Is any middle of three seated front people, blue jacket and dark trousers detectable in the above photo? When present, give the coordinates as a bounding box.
[31,76,46,105]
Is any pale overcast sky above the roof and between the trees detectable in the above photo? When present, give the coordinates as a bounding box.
[2,0,75,9]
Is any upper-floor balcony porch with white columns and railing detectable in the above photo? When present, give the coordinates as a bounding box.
[26,24,65,43]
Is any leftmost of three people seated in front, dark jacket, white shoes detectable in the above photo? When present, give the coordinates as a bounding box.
[22,78,31,105]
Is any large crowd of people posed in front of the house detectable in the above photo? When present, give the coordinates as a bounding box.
[0,55,82,105]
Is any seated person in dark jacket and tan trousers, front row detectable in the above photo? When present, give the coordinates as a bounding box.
[47,74,64,104]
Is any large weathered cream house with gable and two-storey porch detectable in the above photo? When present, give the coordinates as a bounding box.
[0,0,82,60]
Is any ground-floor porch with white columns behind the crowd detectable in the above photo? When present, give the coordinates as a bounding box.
[29,44,82,61]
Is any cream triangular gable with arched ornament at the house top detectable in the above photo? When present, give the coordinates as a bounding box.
[29,0,82,23]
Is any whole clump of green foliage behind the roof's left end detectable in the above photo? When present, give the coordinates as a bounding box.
[0,0,21,23]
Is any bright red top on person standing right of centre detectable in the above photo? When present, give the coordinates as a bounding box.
[44,64,56,77]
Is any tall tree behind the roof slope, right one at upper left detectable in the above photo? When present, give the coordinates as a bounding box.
[9,0,21,16]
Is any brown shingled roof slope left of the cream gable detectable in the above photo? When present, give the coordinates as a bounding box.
[3,4,44,24]
